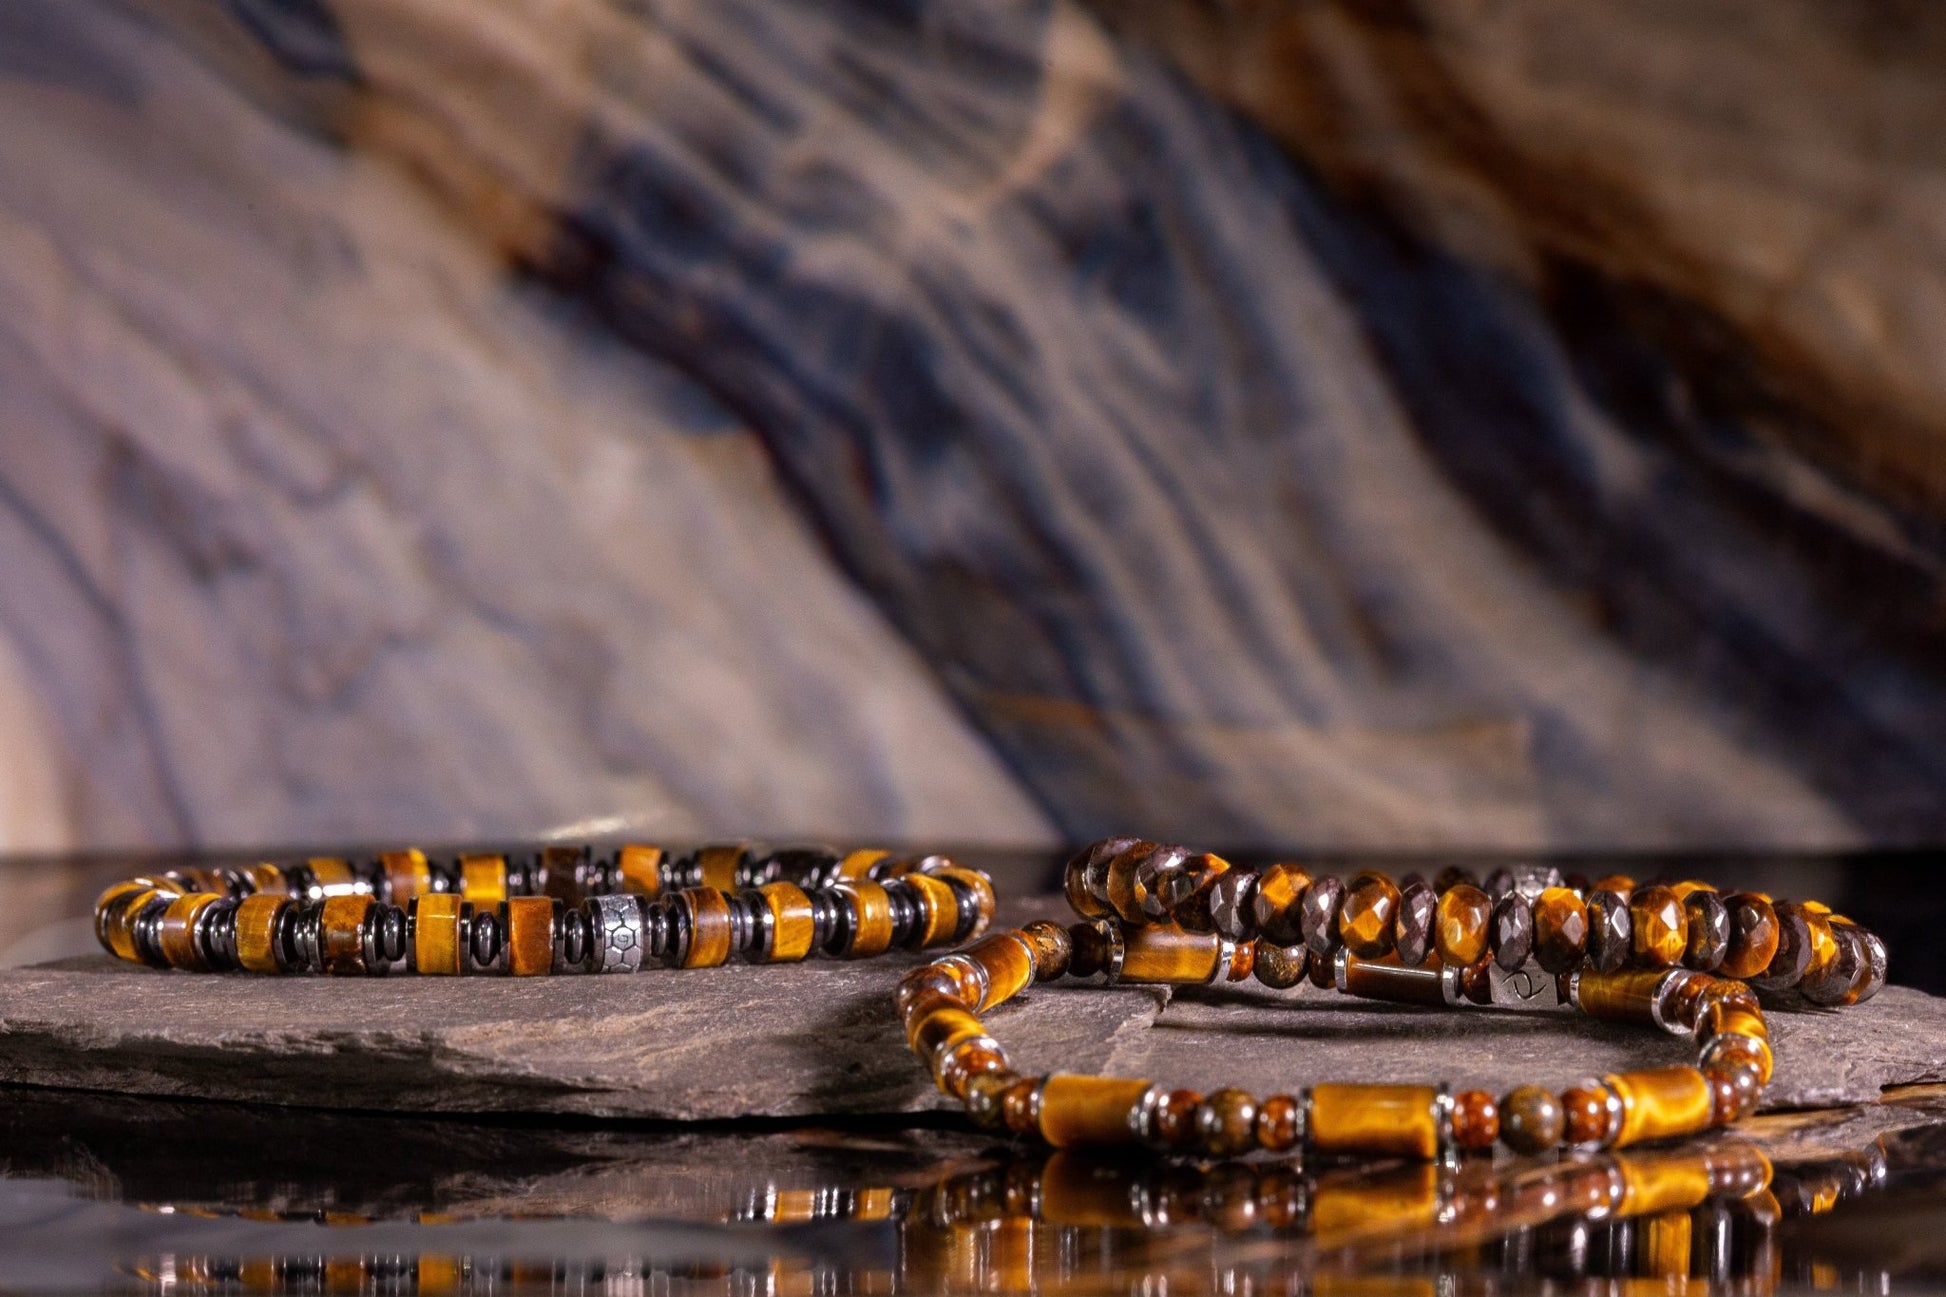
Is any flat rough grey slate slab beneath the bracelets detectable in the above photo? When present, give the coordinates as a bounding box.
[0,903,1946,1120]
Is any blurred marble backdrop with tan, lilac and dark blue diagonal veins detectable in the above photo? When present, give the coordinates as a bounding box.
[0,0,1946,847]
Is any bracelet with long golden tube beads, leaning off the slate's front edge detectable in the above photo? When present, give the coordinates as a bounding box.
[897,839,1882,1159]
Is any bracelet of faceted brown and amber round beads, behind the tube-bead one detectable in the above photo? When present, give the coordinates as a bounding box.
[1064,837,1888,1005]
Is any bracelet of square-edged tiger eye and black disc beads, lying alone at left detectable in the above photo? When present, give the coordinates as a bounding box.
[95,843,994,978]
